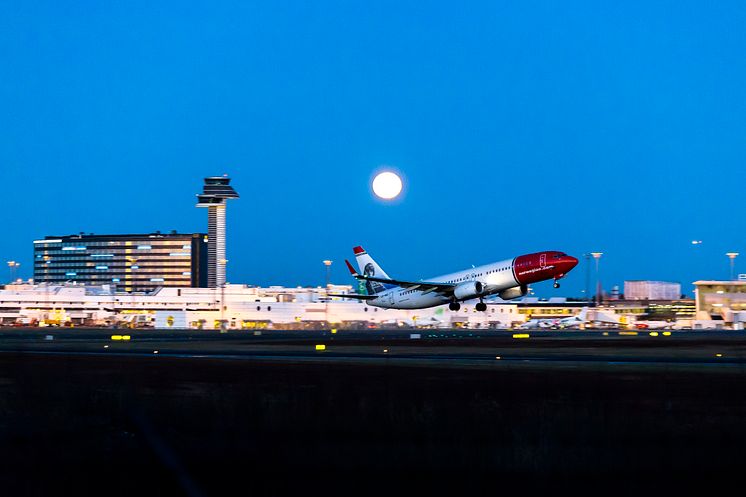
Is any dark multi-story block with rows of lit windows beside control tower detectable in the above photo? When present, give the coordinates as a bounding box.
[34,232,207,292]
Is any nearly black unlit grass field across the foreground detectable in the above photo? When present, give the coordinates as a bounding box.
[0,332,746,496]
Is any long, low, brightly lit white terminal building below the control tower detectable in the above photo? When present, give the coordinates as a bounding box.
[0,283,524,329]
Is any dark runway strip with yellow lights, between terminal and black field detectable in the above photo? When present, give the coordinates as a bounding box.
[0,328,746,368]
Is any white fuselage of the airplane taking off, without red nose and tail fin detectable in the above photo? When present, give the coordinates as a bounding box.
[367,259,520,309]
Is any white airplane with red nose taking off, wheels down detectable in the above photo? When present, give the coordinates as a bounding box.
[330,247,578,311]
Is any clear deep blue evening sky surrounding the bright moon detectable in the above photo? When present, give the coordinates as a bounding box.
[0,1,746,296]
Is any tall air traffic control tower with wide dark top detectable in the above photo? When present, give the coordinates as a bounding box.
[197,175,238,288]
